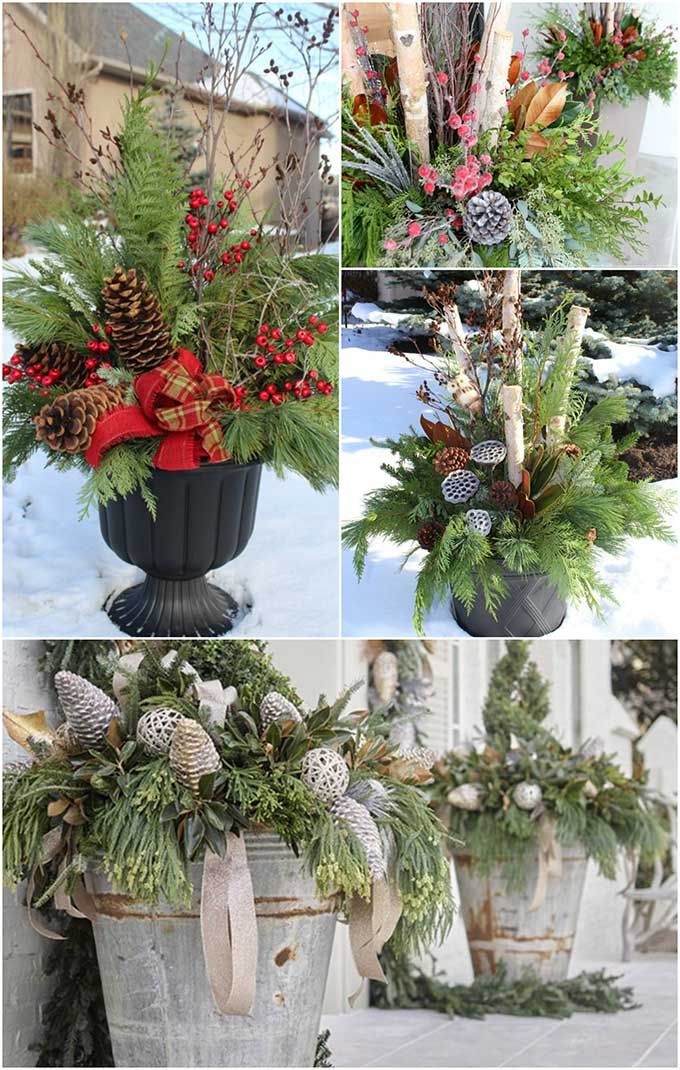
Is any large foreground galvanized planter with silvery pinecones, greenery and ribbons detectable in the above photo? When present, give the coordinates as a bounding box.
[3,643,452,1067]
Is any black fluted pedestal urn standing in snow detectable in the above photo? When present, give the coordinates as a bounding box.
[99,461,262,638]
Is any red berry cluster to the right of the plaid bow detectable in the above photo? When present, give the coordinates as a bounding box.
[252,316,333,406]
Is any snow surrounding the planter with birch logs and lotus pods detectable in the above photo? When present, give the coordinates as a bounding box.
[340,319,679,639]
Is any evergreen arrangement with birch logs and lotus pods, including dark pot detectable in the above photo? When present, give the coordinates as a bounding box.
[344,270,673,637]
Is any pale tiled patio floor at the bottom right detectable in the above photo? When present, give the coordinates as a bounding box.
[322,956,678,1068]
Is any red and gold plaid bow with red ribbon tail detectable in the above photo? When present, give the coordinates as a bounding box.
[86,349,235,472]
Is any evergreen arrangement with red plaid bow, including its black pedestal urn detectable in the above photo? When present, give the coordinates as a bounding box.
[3,12,337,636]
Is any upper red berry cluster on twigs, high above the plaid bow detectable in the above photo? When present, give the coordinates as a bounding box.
[177,185,258,282]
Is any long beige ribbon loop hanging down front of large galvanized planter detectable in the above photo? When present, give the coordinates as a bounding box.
[201,832,258,1014]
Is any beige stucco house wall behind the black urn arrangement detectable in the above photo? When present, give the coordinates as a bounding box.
[3,4,321,245]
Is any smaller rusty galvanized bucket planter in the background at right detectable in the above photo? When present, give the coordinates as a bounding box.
[453,844,587,981]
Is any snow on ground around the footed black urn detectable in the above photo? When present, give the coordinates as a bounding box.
[4,455,338,638]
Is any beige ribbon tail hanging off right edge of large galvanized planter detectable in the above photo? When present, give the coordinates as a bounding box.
[349,881,401,1007]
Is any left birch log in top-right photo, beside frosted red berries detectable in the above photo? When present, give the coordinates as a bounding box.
[387,3,430,166]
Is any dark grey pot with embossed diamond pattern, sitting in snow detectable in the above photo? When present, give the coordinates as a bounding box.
[451,569,567,639]
